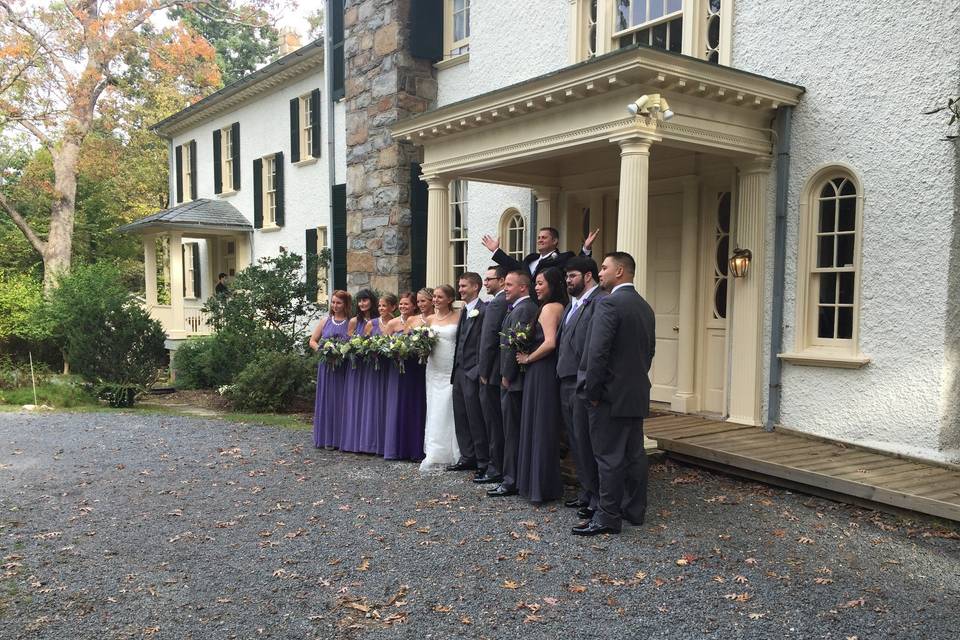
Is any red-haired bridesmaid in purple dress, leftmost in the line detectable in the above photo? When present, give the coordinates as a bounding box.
[310,289,352,449]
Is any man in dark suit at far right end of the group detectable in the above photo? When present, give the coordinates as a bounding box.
[573,251,656,536]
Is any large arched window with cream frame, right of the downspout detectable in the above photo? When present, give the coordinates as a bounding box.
[784,166,869,367]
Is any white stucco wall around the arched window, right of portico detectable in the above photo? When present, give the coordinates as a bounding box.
[732,0,960,459]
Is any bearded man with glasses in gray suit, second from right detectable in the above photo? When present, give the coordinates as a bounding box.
[557,257,607,520]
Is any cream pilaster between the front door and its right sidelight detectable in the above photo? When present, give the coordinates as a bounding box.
[671,177,700,413]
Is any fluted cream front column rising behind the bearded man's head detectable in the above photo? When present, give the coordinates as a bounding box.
[615,135,656,296]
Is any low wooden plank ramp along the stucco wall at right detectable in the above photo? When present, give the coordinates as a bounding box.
[644,415,960,521]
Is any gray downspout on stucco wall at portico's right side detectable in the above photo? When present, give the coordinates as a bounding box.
[764,105,793,431]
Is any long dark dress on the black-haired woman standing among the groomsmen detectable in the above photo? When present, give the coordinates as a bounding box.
[517,322,563,502]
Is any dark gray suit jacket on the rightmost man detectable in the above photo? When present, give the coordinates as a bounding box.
[581,287,656,418]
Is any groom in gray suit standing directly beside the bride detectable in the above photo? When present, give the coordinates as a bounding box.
[447,271,490,478]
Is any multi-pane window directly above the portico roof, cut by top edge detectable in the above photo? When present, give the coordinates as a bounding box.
[614,0,683,53]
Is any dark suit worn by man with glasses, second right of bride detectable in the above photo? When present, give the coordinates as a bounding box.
[477,292,507,476]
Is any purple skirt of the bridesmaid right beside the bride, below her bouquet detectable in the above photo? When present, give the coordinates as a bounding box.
[383,330,427,461]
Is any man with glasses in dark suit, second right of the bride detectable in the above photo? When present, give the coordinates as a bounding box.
[473,266,507,484]
